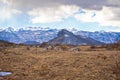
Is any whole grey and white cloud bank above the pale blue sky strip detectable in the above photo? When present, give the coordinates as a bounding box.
[0,0,120,27]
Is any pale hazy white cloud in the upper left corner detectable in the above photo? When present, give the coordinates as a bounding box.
[0,0,22,23]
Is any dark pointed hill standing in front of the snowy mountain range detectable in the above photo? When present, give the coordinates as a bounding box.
[48,29,103,45]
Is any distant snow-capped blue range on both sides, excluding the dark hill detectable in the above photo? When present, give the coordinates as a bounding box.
[0,27,120,43]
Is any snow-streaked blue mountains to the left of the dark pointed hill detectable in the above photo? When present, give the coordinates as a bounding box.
[0,28,57,43]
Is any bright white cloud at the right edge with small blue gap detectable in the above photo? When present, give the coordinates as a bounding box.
[74,7,120,26]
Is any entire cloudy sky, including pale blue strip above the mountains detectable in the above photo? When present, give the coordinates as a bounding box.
[0,0,120,32]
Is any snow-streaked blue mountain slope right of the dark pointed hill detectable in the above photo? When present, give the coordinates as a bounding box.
[75,31,120,43]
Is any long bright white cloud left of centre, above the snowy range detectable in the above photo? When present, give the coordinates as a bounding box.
[28,5,79,23]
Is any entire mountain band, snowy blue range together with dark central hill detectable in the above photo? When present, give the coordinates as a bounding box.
[0,27,120,45]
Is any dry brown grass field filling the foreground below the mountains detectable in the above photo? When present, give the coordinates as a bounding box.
[0,46,120,80]
